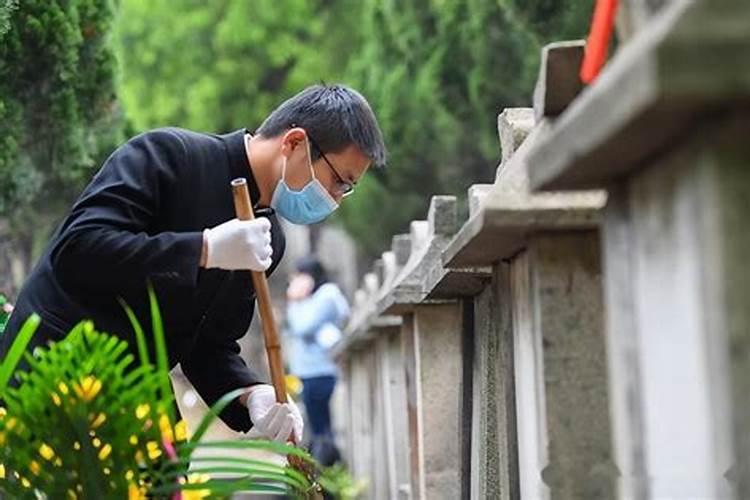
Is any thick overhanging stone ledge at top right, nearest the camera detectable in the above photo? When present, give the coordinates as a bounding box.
[529,0,750,190]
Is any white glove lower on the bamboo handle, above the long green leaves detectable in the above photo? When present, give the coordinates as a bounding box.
[247,384,304,443]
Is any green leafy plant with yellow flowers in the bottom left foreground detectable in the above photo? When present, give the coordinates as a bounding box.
[0,292,354,500]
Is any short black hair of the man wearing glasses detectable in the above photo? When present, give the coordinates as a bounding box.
[256,84,387,165]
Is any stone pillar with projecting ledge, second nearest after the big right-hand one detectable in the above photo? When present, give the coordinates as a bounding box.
[444,93,615,499]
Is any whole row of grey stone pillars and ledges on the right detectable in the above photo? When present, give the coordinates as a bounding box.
[336,0,750,499]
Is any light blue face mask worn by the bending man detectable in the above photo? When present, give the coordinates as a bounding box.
[271,142,339,224]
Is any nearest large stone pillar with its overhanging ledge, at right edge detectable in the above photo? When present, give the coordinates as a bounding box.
[530,1,750,499]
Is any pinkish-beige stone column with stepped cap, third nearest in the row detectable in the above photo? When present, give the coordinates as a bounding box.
[377,196,465,499]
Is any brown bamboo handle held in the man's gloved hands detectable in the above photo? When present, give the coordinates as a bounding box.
[232,177,287,403]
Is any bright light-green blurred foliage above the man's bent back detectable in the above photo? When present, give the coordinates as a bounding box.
[117,0,330,131]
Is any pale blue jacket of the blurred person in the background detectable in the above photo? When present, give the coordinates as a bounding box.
[285,283,349,379]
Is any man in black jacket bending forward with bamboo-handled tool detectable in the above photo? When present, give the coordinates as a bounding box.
[0,85,386,442]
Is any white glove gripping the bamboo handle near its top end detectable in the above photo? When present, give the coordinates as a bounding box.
[203,217,273,271]
